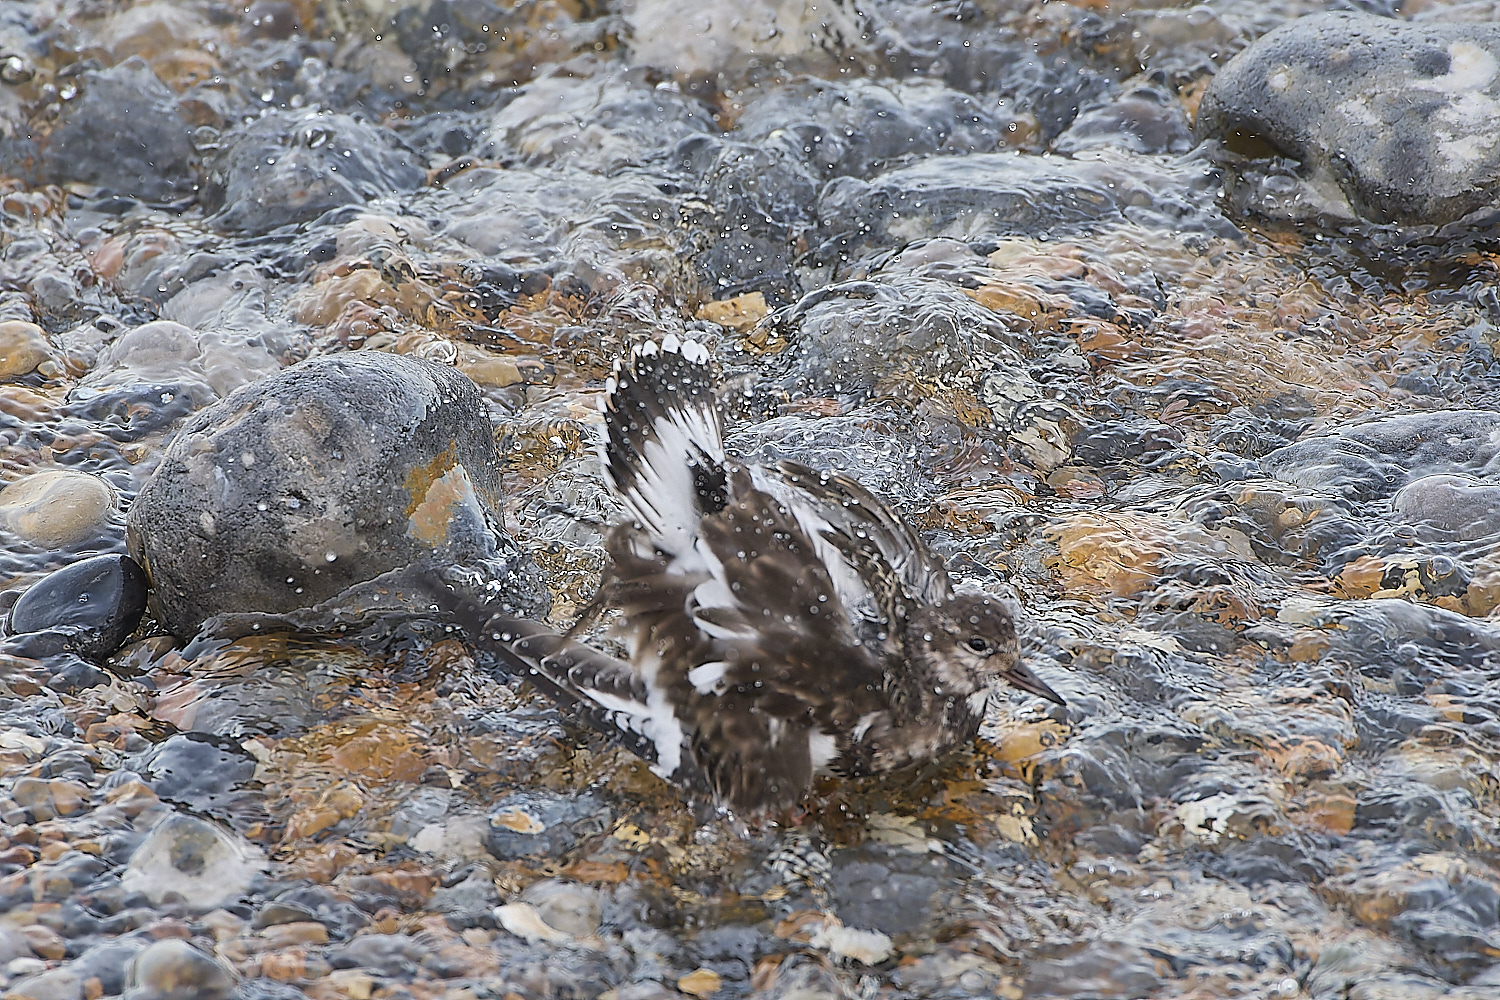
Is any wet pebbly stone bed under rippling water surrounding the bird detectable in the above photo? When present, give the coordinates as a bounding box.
[0,0,1500,1000]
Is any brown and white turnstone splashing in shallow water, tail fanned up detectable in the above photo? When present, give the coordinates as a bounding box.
[438,336,1064,814]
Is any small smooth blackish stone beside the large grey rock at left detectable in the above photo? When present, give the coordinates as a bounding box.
[9,555,146,658]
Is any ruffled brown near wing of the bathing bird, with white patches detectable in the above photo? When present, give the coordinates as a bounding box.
[591,463,888,810]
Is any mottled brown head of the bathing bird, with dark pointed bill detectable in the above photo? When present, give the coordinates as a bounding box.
[912,594,1065,705]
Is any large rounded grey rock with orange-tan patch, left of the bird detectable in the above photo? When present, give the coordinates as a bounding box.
[129,352,545,636]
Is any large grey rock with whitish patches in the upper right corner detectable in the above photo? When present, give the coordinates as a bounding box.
[1197,13,1500,225]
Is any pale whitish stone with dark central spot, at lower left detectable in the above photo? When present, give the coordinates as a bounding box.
[120,813,266,913]
